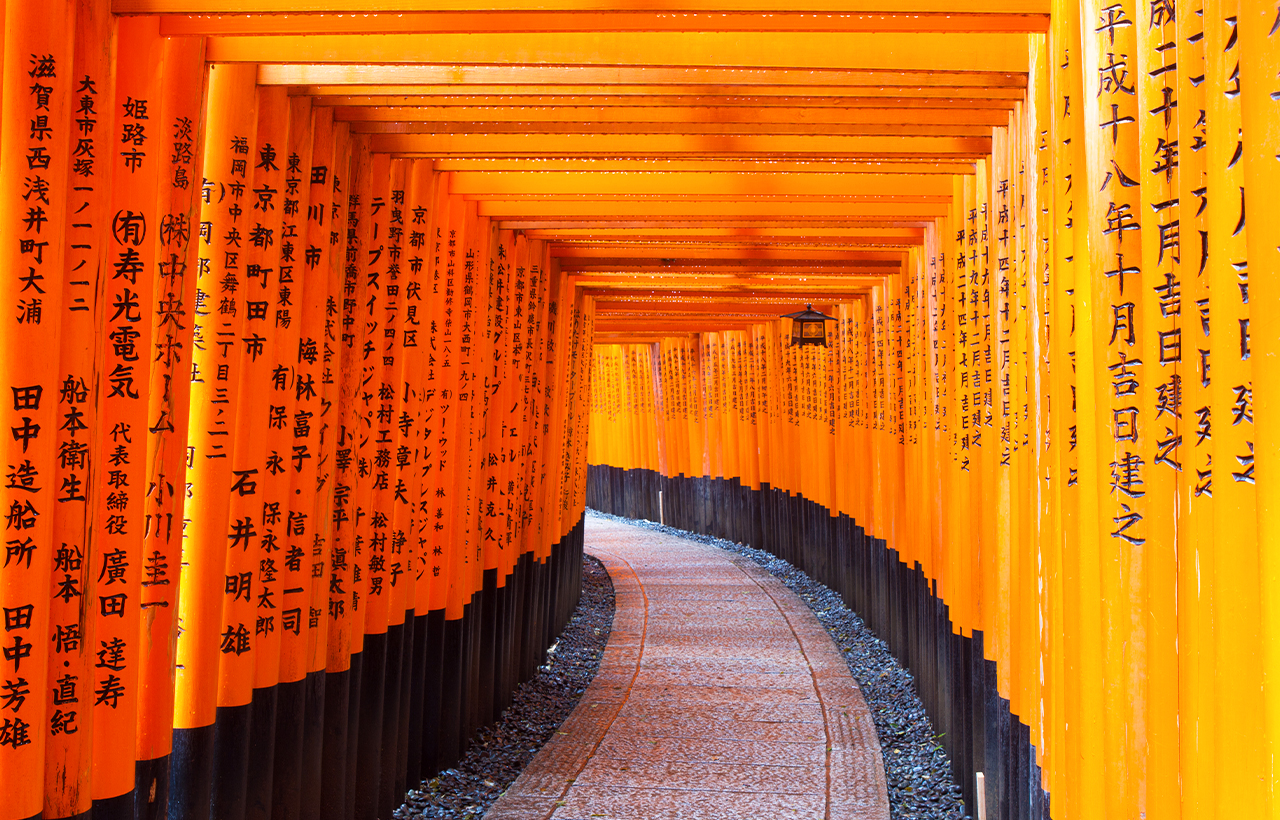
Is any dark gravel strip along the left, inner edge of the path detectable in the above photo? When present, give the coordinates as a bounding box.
[393,555,614,820]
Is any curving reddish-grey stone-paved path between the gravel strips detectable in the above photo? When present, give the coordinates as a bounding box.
[485,518,888,820]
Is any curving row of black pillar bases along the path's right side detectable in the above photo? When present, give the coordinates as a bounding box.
[586,464,1050,820]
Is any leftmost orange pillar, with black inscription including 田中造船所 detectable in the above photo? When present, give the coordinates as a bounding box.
[0,1,76,817]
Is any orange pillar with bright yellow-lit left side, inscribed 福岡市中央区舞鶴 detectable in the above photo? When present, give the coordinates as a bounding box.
[169,64,257,819]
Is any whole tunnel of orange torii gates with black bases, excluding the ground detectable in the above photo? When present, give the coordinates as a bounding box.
[0,0,1280,820]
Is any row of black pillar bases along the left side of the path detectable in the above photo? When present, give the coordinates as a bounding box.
[142,511,584,820]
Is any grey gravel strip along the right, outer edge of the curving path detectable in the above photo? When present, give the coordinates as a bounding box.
[586,509,968,820]
